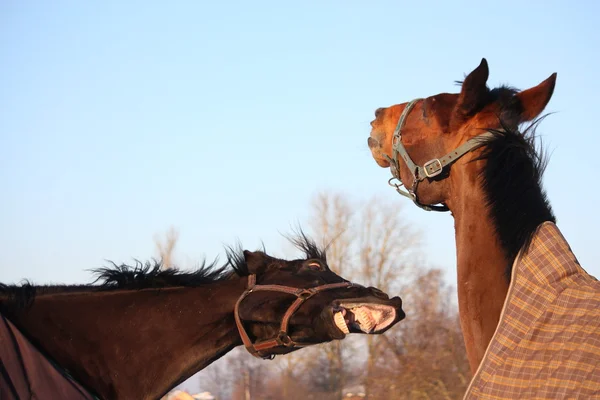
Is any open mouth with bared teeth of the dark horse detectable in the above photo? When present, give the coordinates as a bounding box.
[333,303,404,335]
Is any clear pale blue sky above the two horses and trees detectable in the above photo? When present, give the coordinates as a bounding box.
[0,0,600,292]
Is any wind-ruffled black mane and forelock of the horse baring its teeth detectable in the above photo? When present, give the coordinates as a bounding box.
[0,231,326,311]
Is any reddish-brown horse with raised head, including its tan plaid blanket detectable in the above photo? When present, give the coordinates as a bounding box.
[367,58,600,398]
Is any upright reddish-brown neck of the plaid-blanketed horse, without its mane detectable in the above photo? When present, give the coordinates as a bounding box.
[447,163,509,372]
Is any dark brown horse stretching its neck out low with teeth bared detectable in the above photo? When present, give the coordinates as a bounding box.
[0,234,404,400]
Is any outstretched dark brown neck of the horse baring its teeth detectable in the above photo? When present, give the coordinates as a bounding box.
[5,278,246,399]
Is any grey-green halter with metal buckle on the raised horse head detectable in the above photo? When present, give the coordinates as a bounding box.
[384,99,494,211]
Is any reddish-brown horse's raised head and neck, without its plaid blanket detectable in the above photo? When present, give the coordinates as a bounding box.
[368,59,556,372]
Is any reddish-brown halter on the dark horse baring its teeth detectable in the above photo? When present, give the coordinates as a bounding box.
[233,274,360,360]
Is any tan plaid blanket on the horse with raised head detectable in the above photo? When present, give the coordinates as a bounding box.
[464,222,600,400]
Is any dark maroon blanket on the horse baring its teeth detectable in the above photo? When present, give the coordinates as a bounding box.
[0,314,95,400]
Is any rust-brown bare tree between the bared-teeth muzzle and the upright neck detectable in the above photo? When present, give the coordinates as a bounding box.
[373,269,471,399]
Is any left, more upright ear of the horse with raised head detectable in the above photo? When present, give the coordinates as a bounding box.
[455,58,490,116]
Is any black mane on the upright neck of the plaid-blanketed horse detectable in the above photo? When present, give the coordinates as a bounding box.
[477,108,556,280]
